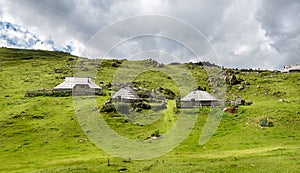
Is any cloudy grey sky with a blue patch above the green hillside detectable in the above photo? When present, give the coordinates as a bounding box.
[0,0,300,69]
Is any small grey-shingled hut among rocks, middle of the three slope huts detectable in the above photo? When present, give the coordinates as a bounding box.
[112,87,140,101]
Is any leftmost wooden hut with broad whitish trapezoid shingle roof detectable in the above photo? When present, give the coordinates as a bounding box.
[53,77,101,95]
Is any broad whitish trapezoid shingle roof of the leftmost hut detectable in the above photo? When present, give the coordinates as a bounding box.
[54,77,101,89]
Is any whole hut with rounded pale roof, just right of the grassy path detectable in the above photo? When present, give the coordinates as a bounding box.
[181,90,218,108]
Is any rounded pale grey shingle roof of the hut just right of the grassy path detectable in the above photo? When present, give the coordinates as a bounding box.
[181,90,217,101]
